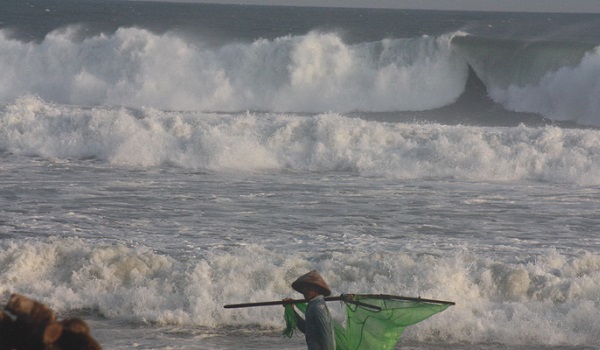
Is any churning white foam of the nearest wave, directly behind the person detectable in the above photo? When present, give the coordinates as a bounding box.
[0,238,600,345]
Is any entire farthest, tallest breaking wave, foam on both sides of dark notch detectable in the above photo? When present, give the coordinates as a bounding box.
[0,27,600,126]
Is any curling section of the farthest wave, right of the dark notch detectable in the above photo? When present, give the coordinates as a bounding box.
[453,36,600,126]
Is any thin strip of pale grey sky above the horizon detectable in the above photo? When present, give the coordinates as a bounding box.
[155,0,600,13]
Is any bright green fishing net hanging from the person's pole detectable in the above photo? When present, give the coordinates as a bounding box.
[284,295,452,350]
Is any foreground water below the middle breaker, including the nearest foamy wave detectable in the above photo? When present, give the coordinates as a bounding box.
[0,149,600,349]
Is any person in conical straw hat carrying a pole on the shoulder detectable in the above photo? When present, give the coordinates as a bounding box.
[286,270,335,350]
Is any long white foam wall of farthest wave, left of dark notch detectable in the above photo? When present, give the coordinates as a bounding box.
[0,27,467,112]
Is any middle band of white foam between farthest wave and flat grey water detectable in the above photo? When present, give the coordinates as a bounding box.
[0,97,600,185]
